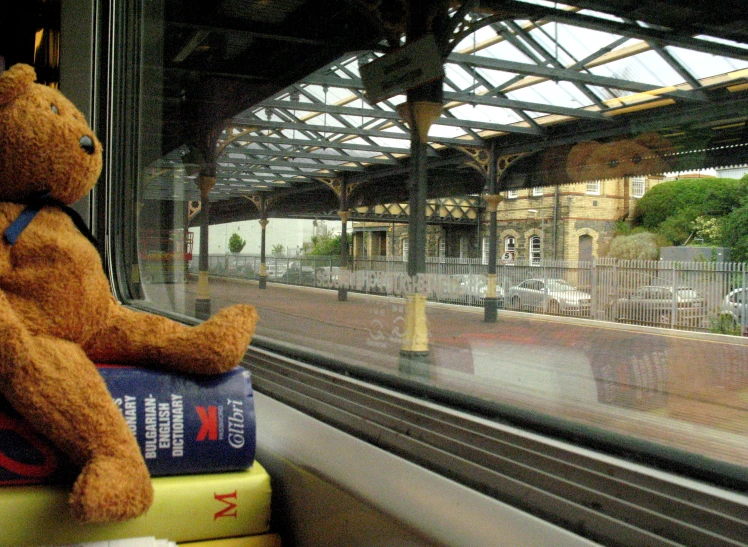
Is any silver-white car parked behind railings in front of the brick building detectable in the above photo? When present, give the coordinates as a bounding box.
[506,279,592,316]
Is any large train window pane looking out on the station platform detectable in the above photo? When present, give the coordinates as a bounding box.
[115,0,748,488]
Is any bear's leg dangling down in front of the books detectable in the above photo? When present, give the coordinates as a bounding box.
[0,329,153,522]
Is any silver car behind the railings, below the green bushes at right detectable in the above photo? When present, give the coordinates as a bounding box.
[611,285,706,327]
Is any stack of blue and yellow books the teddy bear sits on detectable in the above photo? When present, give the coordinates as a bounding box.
[0,365,280,547]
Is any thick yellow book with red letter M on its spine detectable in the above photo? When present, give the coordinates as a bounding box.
[0,462,270,547]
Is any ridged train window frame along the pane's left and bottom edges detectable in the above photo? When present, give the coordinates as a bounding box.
[97,3,745,545]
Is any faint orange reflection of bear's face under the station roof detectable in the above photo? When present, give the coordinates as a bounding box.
[566,133,675,182]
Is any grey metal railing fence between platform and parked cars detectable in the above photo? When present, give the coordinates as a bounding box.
[189,255,748,334]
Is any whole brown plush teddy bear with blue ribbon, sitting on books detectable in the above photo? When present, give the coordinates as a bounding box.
[0,64,257,522]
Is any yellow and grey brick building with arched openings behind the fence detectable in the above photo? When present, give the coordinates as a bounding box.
[352,177,664,262]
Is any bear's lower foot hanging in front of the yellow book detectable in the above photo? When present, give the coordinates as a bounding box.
[70,457,153,523]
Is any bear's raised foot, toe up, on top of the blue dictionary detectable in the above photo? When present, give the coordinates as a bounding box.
[193,304,257,373]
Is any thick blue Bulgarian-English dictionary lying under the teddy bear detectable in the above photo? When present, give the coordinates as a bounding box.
[0,365,256,485]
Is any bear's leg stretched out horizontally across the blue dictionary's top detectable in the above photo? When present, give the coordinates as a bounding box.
[84,304,257,374]
